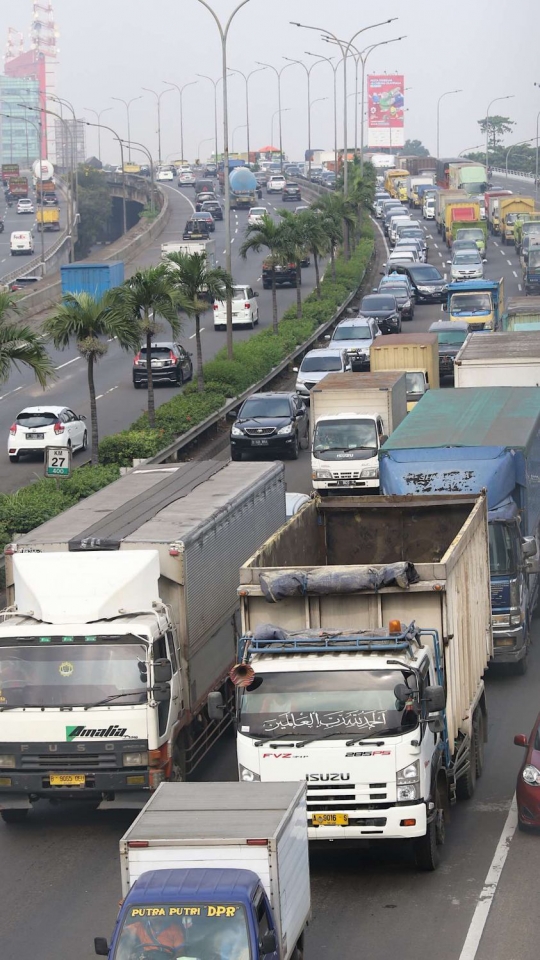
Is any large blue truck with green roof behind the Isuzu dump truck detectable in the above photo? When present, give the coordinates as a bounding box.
[380,387,540,673]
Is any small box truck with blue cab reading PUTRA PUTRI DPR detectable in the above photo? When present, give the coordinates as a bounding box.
[95,782,310,960]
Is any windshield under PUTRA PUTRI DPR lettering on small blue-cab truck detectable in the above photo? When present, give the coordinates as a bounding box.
[114,902,250,960]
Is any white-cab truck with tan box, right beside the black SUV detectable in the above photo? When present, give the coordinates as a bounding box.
[310,371,407,496]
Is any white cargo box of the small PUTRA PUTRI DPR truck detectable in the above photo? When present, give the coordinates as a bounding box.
[120,781,310,960]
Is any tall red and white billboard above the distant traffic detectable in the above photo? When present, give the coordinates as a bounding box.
[368,73,405,148]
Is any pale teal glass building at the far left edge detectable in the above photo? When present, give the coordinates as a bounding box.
[0,76,40,169]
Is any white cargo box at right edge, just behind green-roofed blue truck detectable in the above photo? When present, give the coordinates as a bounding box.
[454,330,540,387]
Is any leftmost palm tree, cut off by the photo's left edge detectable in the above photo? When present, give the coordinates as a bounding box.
[0,291,54,387]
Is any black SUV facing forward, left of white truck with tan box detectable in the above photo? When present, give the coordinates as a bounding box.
[231,393,309,460]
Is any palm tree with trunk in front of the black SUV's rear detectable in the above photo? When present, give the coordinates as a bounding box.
[108,263,183,429]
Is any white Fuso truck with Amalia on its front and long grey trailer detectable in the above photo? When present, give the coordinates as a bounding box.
[0,461,285,822]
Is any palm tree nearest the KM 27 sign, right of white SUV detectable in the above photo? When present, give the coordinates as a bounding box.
[43,293,140,466]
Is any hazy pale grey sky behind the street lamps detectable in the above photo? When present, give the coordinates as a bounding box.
[0,0,540,162]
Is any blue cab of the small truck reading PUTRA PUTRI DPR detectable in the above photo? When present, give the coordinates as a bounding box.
[95,869,279,960]
